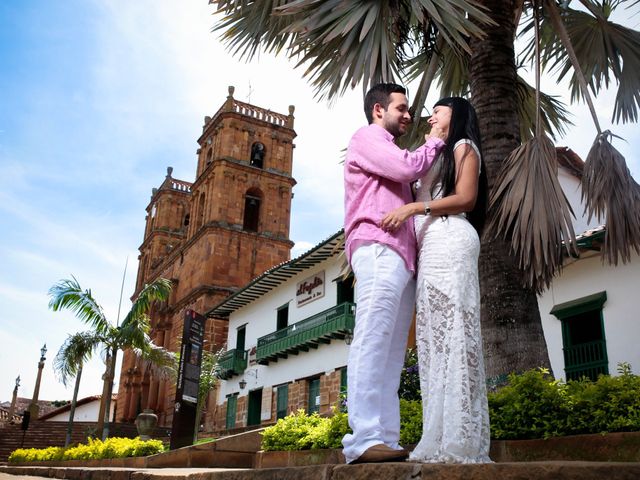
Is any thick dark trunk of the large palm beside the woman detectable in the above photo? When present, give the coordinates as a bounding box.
[470,0,550,384]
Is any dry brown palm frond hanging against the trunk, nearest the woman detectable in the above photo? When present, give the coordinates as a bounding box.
[485,135,578,293]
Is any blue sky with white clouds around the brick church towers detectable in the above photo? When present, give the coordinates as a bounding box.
[0,0,640,400]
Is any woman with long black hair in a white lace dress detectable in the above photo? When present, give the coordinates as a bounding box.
[382,97,491,463]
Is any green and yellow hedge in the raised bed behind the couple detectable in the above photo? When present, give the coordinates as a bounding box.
[262,364,640,450]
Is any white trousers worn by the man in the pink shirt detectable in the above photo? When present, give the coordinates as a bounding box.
[342,243,415,463]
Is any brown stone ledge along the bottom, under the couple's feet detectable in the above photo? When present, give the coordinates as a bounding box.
[0,461,640,480]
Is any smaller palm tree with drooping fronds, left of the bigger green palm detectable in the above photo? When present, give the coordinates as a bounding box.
[53,331,102,447]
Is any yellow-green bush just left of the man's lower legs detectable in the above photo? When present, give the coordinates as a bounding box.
[262,409,351,451]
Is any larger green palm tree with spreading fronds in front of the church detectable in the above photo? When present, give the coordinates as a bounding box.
[49,277,174,438]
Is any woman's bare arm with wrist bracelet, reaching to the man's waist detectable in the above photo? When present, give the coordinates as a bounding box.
[380,143,480,231]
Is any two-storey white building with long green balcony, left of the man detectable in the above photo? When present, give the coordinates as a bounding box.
[207,231,355,429]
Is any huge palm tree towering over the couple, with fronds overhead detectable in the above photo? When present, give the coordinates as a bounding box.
[212,0,640,382]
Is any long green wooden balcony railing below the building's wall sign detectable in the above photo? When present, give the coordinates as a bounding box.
[256,302,356,365]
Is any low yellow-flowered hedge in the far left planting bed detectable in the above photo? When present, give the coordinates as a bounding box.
[9,437,164,462]
